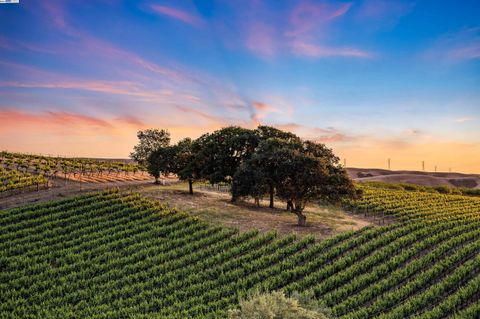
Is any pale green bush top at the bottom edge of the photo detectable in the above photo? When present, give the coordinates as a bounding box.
[228,291,327,319]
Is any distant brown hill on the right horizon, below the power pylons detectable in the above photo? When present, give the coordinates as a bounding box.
[347,168,480,188]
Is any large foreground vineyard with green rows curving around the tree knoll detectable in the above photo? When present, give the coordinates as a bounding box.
[0,187,480,319]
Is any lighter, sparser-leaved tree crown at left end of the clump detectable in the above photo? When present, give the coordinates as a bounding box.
[130,129,170,165]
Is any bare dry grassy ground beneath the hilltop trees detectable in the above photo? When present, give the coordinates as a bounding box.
[138,183,372,238]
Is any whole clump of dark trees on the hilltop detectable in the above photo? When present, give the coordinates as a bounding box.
[131,126,357,226]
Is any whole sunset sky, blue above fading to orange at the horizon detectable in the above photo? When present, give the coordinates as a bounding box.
[0,0,480,173]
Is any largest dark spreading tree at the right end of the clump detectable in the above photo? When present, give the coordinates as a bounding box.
[232,135,357,220]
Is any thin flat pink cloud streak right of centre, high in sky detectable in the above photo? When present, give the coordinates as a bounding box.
[292,41,372,58]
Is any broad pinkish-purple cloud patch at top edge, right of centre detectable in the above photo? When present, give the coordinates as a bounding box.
[221,1,373,60]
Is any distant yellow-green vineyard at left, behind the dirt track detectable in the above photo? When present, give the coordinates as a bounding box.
[0,152,150,191]
